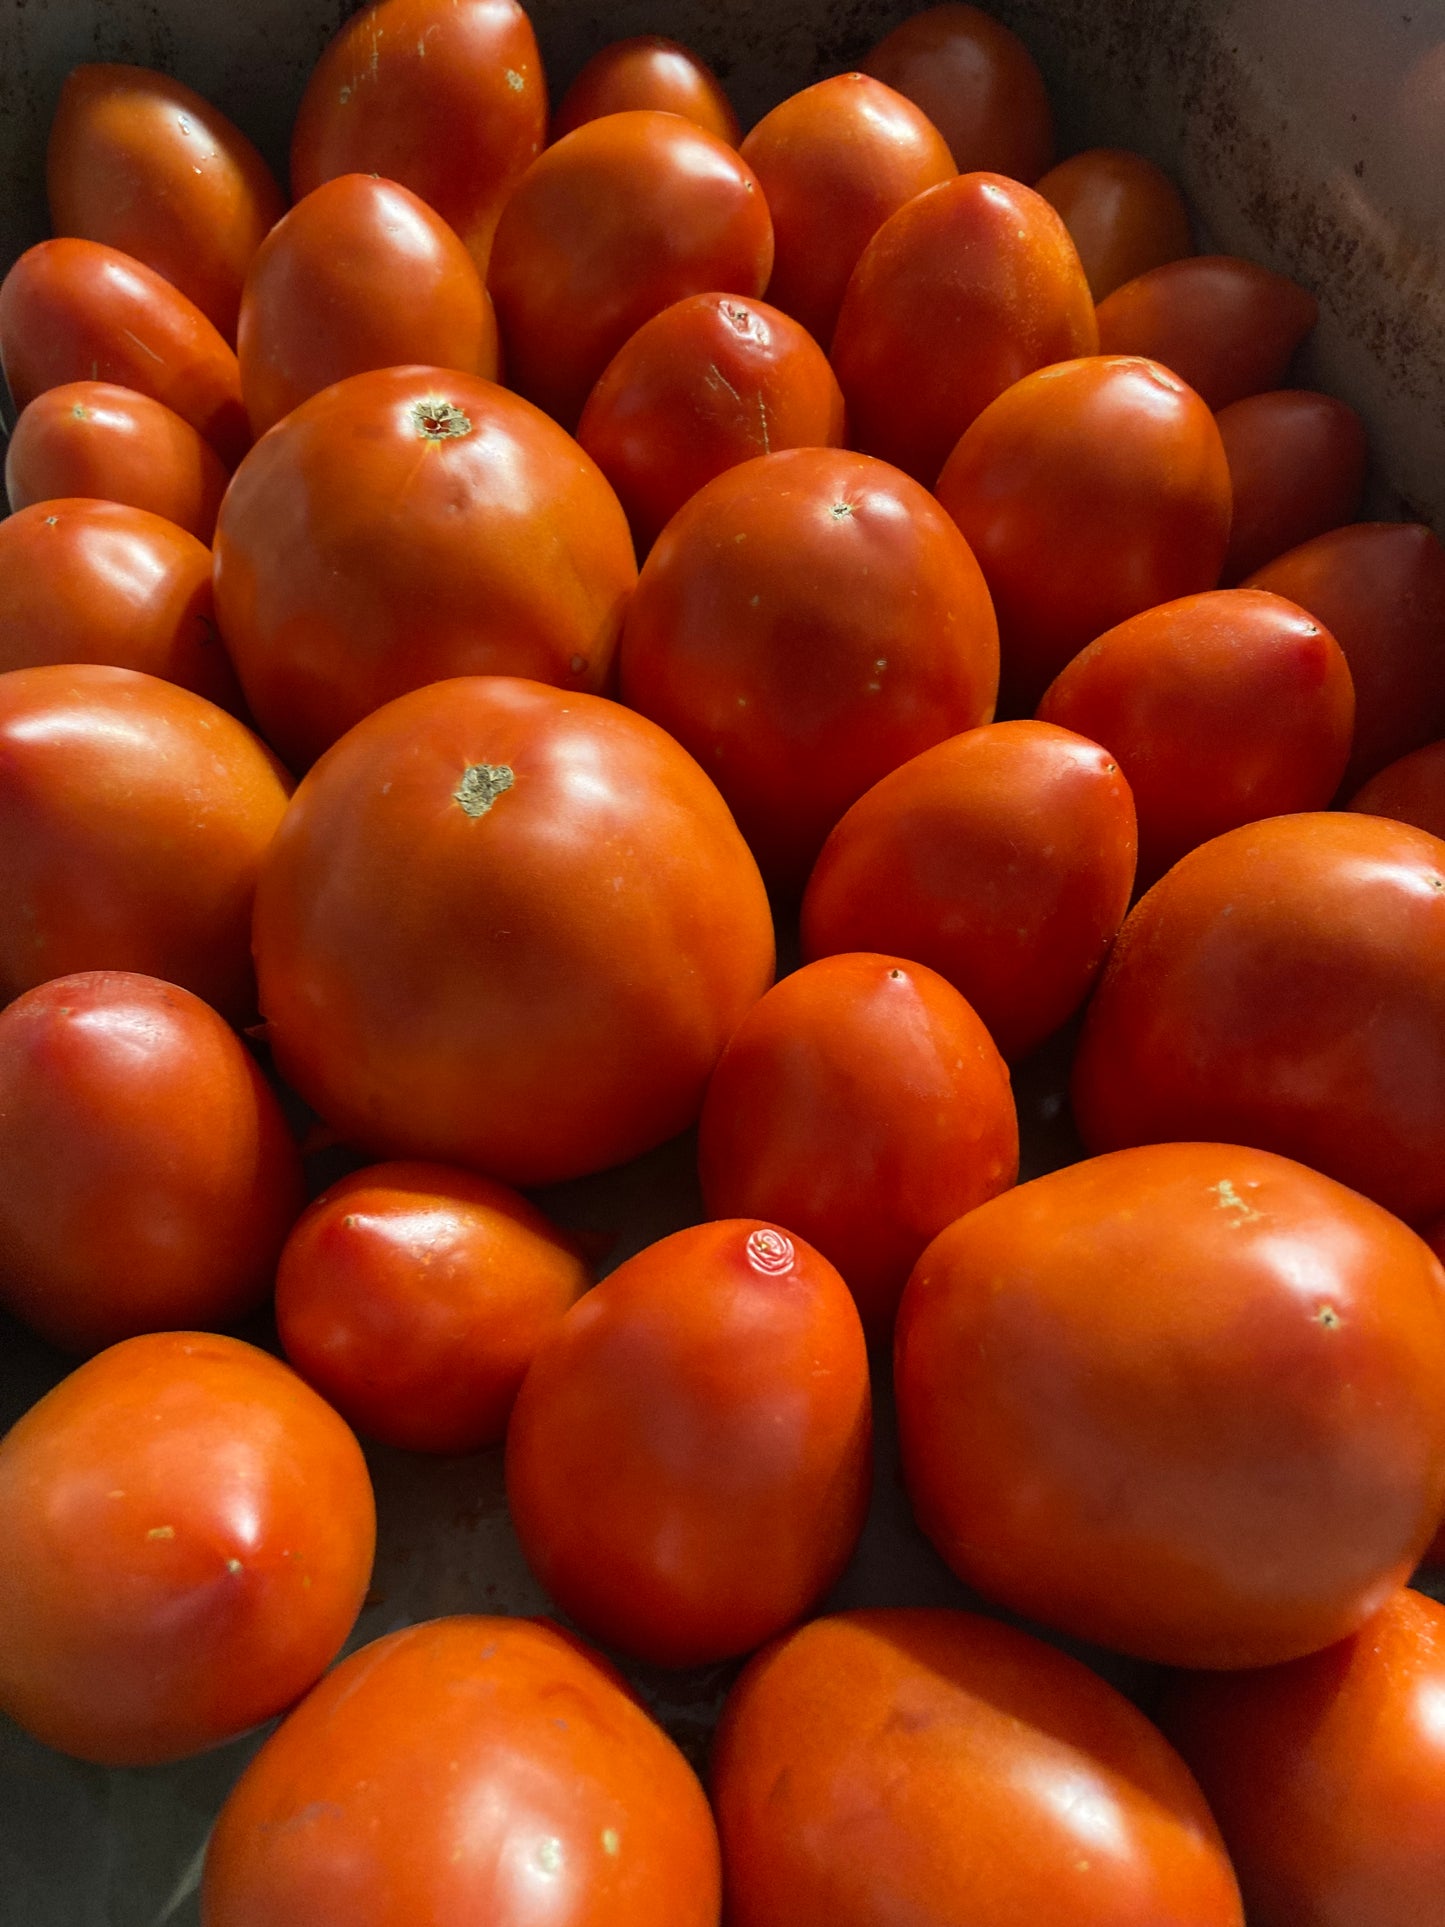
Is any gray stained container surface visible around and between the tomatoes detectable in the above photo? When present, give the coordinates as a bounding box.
[0,0,1445,1927]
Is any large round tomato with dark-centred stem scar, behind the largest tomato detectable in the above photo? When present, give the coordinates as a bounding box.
[216,368,638,769]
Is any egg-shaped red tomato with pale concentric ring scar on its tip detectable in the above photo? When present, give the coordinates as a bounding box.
[507,1218,873,1667]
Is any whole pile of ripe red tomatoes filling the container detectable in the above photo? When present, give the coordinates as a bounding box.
[0,0,1445,1927]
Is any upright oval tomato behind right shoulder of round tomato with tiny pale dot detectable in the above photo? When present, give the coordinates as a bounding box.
[936,355,1229,709]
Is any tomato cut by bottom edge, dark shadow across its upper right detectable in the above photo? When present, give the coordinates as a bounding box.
[711,1607,1245,1927]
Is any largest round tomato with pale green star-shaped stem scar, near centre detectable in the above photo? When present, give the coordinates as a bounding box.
[254,676,773,1185]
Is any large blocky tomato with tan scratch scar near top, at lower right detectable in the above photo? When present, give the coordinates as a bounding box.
[894,1140,1445,1667]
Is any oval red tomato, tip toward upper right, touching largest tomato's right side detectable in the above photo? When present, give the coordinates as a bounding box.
[801,723,1135,1058]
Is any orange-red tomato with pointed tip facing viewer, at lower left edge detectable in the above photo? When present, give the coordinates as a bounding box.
[0,1332,376,1767]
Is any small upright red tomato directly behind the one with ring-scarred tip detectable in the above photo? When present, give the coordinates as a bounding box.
[697,952,1019,1343]
